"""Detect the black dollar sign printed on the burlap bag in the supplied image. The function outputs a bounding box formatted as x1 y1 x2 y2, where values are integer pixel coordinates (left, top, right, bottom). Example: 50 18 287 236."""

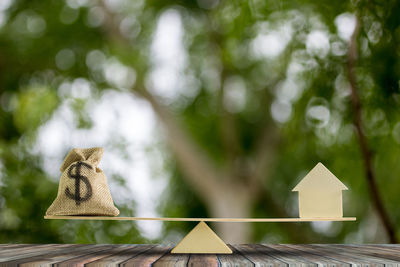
65 161 92 205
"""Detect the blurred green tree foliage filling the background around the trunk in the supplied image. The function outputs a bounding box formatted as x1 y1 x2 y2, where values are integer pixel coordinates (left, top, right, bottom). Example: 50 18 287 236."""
0 0 400 243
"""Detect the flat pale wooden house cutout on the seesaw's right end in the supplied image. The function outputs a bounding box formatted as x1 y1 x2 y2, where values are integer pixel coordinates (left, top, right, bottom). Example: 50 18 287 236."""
292 162 348 218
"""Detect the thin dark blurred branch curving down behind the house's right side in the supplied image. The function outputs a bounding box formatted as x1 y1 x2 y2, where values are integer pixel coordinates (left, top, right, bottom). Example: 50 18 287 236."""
347 17 398 243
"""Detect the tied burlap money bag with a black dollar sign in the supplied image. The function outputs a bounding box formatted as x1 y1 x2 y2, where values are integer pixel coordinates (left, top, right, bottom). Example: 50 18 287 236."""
46 147 119 216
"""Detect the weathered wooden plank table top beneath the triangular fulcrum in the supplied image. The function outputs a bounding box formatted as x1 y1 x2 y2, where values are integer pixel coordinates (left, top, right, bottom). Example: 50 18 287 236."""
0 244 400 267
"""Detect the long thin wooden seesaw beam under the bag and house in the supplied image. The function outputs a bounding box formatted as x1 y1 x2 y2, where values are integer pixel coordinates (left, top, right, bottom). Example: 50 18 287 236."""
44 215 356 222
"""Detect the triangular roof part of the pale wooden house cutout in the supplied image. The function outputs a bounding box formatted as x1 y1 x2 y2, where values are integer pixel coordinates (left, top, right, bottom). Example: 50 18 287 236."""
292 162 348 191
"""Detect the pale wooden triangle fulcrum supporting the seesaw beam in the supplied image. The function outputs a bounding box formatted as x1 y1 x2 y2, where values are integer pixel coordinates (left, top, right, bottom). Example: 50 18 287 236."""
171 221 232 254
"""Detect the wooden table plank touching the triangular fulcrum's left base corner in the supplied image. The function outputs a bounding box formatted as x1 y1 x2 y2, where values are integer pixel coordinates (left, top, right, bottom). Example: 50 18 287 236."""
117 245 171 267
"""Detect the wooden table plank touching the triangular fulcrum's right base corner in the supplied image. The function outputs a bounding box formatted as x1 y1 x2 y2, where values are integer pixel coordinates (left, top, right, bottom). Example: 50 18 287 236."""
233 244 287 267
